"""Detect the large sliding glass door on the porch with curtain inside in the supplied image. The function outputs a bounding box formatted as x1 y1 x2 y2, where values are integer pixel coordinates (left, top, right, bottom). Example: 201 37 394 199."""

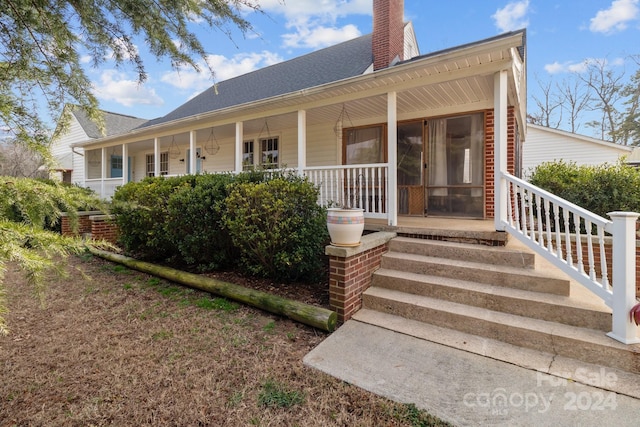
397 113 484 218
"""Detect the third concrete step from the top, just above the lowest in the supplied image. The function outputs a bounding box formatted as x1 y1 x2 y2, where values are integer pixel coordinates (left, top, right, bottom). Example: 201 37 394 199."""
372 268 611 332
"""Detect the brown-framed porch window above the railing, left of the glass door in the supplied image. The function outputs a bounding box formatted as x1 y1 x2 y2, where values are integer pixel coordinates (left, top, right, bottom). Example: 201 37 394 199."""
344 126 385 165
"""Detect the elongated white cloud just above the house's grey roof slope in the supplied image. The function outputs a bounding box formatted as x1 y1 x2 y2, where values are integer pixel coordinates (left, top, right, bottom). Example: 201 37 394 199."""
161 51 282 92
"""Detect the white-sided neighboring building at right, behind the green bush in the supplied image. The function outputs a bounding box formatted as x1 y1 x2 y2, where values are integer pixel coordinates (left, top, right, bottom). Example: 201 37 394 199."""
522 124 634 177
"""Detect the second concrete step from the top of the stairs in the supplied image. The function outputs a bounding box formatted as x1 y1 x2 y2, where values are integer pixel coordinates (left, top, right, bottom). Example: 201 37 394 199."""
381 252 570 296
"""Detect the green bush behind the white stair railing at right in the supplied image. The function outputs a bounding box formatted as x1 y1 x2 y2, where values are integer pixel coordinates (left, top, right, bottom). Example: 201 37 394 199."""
530 161 640 218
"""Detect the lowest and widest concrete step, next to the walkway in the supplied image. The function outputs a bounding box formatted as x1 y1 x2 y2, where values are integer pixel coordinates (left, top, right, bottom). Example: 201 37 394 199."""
363 287 640 374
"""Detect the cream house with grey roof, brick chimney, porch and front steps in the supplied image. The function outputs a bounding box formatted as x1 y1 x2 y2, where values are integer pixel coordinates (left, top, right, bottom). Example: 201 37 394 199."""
58 0 640 384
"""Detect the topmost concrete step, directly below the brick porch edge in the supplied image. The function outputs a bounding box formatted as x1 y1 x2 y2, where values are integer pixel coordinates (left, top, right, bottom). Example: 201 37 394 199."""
389 237 535 269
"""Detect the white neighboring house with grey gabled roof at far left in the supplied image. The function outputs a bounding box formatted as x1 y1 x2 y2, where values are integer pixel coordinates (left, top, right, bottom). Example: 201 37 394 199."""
51 105 147 186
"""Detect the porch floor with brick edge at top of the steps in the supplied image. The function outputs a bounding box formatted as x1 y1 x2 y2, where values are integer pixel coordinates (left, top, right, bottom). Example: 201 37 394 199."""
365 216 508 246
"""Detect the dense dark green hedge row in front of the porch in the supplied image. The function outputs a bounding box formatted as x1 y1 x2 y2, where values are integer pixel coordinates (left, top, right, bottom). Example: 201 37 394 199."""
112 171 328 280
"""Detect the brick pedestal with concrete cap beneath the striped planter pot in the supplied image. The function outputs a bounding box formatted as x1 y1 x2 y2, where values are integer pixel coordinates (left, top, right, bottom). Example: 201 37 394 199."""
325 232 396 323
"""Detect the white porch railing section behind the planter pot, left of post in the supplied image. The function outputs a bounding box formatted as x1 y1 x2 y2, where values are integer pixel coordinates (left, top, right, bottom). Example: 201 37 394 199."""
304 163 389 218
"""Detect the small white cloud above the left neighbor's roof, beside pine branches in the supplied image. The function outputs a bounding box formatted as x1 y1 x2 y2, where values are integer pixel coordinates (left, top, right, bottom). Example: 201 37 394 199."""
93 70 164 107
